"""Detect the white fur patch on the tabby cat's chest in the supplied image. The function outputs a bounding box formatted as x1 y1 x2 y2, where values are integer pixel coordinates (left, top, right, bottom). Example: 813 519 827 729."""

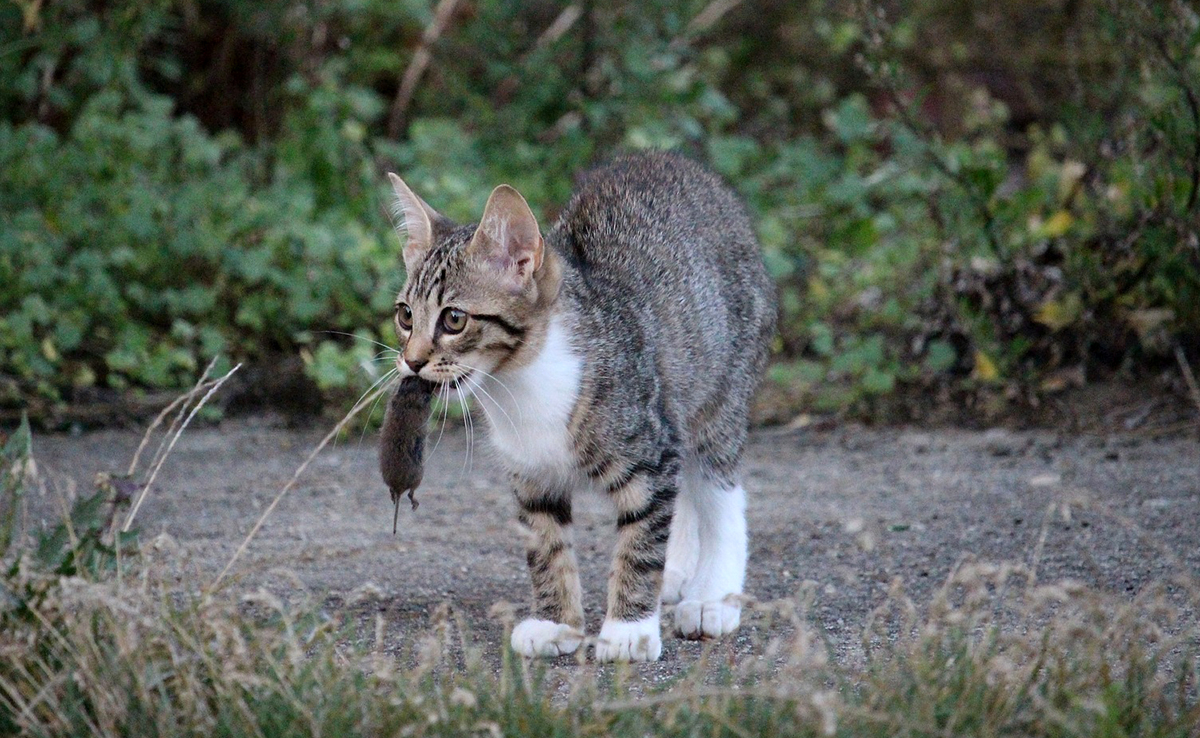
475 318 583 479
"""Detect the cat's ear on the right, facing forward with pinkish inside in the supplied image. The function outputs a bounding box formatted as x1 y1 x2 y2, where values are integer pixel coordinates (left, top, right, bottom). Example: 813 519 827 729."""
470 185 546 289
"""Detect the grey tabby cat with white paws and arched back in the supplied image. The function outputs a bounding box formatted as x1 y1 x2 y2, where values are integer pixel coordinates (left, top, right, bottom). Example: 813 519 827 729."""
389 152 776 661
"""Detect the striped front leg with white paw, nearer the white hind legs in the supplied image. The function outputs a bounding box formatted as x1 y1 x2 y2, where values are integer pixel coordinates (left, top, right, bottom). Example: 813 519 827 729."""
595 452 678 661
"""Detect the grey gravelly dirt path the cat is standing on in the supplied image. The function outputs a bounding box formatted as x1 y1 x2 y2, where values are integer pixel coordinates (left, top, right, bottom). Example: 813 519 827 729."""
35 420 1200 676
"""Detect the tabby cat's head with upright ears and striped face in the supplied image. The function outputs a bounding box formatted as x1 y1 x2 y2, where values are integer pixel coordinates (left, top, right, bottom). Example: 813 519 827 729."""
388 174 562 383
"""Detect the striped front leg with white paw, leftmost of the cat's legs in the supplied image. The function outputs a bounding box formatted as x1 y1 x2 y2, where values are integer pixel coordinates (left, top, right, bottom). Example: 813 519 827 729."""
511 479 583 656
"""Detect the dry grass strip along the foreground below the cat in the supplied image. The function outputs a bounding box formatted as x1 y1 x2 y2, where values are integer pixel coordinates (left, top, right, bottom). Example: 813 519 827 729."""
0 379 1200 737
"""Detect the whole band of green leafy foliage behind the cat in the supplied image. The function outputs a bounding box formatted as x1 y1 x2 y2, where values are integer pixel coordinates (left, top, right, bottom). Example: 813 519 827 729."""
0 0 1200 413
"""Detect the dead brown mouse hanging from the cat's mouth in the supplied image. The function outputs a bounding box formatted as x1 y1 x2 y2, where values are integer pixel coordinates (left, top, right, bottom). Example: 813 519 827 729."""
379 377 436 534
